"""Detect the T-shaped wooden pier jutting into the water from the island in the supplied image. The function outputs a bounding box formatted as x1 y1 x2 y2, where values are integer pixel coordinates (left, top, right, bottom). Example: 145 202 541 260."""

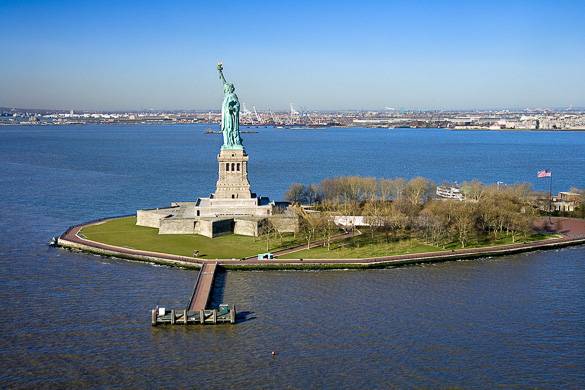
151 263 236 326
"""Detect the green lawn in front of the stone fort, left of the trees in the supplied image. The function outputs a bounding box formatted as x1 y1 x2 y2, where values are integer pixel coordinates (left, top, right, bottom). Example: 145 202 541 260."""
80 217 293 259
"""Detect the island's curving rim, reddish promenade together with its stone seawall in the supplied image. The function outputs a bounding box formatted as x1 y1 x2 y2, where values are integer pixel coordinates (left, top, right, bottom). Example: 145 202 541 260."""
55 217 585 271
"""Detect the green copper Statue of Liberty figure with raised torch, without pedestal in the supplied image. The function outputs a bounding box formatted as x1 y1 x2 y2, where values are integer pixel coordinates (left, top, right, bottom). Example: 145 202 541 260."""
217 63 244 150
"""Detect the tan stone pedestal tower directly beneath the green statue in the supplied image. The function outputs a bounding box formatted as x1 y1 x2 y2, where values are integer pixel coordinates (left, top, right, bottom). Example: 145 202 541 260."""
213 149 252 199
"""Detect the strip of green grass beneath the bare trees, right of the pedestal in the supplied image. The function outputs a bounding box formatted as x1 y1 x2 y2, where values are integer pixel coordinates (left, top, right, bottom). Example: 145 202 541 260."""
280 233 557 259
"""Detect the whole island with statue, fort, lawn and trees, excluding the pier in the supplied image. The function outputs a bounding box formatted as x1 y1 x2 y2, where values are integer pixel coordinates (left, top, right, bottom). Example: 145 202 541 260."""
57 63 585 269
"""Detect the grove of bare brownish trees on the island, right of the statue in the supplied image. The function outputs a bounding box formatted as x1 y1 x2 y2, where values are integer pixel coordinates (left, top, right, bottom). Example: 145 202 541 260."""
287 176 540 248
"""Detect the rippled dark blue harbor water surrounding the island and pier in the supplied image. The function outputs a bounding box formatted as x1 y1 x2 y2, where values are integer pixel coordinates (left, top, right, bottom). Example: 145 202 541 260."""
0 126 585 388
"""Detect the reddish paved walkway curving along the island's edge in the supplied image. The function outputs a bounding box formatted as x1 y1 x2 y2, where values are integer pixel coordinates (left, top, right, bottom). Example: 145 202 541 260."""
59 218 585 265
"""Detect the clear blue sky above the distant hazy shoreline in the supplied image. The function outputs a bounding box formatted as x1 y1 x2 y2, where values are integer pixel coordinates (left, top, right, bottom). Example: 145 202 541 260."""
0 0 585 110
